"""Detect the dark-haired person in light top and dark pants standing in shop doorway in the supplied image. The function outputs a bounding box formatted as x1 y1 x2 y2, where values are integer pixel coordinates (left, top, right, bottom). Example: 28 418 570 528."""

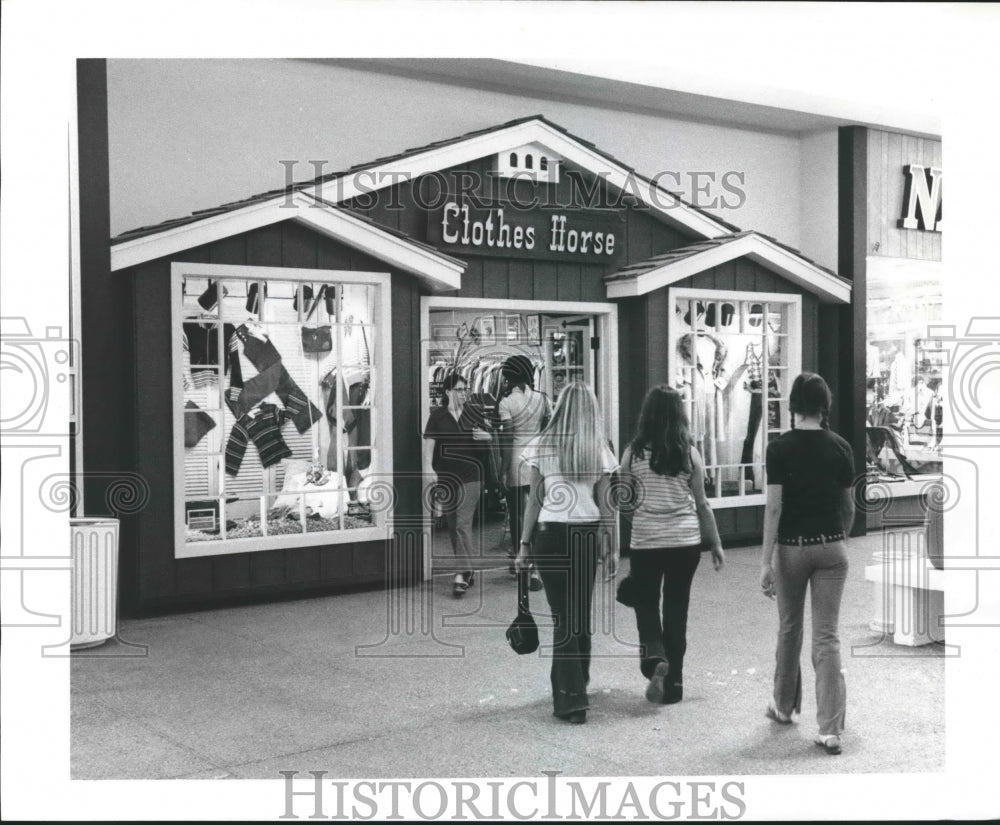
498 355 552 591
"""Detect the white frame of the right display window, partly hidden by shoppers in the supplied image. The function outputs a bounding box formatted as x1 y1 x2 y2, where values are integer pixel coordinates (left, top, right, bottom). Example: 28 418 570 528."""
667 287 802 510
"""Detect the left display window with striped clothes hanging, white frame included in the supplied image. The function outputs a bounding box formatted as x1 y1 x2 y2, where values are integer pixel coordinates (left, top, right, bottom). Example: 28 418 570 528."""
172 264 390 556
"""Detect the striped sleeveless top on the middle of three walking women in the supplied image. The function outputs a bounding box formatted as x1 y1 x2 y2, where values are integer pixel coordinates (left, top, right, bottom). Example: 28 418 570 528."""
631 455 701 550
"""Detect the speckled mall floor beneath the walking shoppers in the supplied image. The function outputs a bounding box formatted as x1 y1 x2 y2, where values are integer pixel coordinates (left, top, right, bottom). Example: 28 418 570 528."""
71 524 945 779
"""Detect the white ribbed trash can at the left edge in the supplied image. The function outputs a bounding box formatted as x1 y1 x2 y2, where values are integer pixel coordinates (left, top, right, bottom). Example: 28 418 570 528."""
69 518 118 650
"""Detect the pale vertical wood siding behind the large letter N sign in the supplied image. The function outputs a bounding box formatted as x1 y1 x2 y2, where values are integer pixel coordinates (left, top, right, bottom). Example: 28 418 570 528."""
865 129 943 261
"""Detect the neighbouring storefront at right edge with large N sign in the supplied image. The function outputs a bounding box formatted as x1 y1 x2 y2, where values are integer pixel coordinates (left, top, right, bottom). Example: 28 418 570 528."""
865 130 947 527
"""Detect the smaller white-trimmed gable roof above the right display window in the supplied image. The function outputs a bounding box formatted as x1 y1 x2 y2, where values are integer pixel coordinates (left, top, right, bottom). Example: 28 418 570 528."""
604 231 851 303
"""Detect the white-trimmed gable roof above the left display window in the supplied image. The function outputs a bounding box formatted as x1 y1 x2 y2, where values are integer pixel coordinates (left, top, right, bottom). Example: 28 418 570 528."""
111 192 466 291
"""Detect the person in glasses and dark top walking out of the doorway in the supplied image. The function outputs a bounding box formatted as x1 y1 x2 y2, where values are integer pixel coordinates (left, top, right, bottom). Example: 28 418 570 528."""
424 372 493 597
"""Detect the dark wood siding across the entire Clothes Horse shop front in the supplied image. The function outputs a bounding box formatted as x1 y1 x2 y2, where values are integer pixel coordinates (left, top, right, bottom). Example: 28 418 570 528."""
116 154 844 612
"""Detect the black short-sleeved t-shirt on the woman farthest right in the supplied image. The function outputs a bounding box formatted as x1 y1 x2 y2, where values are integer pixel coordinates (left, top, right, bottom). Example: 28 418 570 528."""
767 430 854 537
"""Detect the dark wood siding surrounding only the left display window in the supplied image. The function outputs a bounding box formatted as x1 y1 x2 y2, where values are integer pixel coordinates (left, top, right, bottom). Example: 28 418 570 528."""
125 222 420 612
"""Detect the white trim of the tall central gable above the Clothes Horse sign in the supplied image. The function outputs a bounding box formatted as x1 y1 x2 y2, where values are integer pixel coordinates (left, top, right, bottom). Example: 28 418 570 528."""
303 115 738 238
